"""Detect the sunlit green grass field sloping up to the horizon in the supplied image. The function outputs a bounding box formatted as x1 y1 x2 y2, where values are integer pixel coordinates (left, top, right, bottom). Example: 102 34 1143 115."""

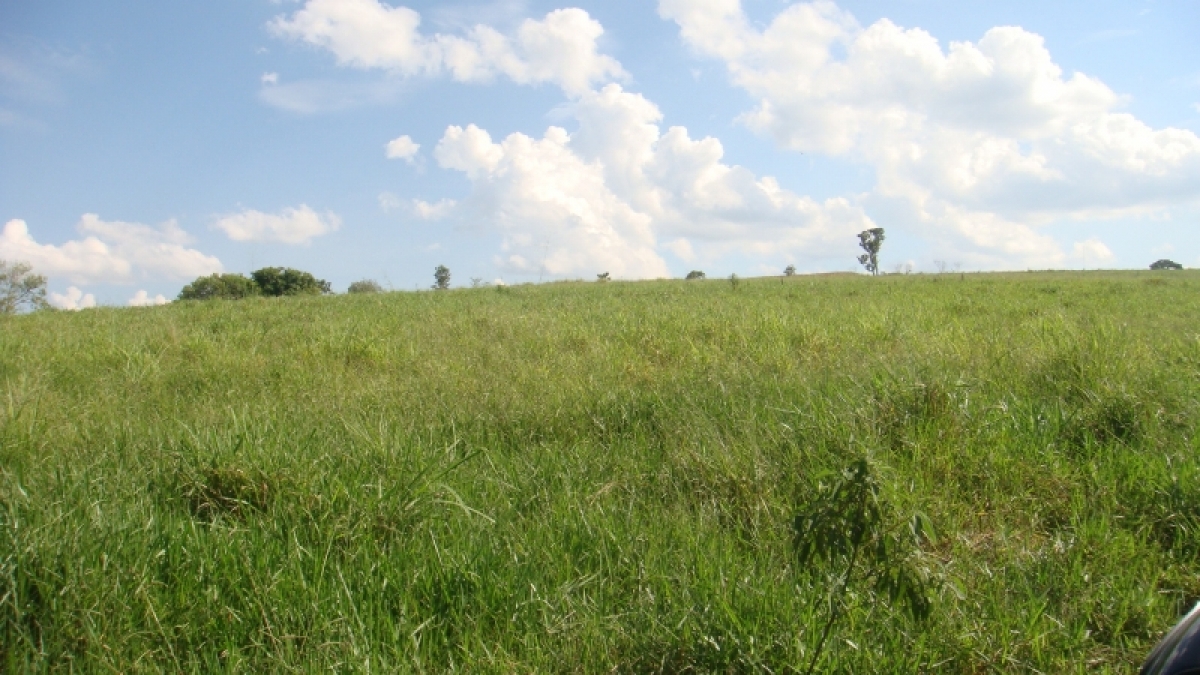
0 271 1200 673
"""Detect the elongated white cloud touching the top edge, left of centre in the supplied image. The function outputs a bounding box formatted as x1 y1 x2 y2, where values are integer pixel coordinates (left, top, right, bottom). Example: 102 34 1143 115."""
269 0 625 95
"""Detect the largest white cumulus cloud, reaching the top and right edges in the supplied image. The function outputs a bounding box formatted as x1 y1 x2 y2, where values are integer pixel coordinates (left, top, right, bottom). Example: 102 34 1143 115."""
659 0 1200 265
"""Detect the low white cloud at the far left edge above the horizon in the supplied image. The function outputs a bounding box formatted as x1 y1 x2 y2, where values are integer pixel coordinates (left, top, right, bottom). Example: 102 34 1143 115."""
0 214 222 281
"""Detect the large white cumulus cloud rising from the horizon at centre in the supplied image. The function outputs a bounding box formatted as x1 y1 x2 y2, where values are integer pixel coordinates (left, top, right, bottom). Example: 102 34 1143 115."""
433 84 872 277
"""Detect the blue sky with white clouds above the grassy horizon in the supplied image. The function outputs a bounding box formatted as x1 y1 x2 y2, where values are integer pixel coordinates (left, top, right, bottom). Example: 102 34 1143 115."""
0 0 1200 309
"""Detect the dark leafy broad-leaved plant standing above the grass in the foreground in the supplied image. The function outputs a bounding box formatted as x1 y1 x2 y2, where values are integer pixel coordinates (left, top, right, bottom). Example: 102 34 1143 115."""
792 459 934 673
